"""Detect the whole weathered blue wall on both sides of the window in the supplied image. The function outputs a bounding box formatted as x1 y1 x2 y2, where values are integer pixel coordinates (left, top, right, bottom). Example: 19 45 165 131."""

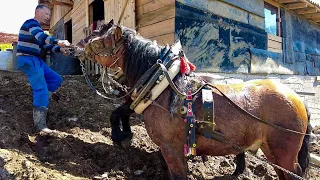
175 0 320 75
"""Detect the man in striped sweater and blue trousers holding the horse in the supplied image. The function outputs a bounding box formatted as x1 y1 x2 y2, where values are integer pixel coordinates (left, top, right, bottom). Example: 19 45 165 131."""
17 5 70 133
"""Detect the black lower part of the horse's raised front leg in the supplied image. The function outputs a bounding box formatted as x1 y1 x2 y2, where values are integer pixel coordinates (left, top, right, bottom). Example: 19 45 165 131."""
110 100 133 143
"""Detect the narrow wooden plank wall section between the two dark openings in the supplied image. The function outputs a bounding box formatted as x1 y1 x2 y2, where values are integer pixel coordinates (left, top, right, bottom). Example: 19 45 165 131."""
71 0 86 44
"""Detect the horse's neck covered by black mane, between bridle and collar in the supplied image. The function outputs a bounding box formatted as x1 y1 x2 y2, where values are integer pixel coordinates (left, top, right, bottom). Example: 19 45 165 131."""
124 36 163 87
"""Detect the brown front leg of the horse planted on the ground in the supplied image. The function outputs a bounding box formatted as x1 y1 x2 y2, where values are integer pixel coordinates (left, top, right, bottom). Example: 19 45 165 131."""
160 144 187 180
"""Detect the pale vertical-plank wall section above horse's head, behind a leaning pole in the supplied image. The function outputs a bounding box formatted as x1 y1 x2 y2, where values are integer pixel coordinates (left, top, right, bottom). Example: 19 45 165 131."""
104 0 136 29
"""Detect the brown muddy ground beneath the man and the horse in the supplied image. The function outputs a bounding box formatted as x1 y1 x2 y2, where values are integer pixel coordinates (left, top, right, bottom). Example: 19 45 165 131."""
0 71 320 180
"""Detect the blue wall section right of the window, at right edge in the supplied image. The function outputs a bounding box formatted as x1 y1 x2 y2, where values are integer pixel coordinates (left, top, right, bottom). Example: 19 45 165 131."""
281 10 320 75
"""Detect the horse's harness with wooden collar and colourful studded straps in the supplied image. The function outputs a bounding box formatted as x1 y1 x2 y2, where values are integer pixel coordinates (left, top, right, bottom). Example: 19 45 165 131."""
124 41 215 157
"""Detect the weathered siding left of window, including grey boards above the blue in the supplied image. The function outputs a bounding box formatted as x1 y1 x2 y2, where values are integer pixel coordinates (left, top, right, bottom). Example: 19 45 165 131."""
175 0 267 73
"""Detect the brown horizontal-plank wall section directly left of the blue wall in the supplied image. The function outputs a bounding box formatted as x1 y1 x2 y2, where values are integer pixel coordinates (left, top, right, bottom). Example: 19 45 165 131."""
136 0 176 45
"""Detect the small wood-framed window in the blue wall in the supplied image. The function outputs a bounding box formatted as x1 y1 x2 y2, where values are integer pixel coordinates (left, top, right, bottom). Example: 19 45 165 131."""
264 2 281 36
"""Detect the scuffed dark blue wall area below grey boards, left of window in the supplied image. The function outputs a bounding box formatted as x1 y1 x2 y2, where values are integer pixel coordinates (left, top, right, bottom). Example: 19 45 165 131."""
175 2 267 73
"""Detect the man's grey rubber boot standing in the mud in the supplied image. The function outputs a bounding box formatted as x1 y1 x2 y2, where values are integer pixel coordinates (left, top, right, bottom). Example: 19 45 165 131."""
33 106 56 133
